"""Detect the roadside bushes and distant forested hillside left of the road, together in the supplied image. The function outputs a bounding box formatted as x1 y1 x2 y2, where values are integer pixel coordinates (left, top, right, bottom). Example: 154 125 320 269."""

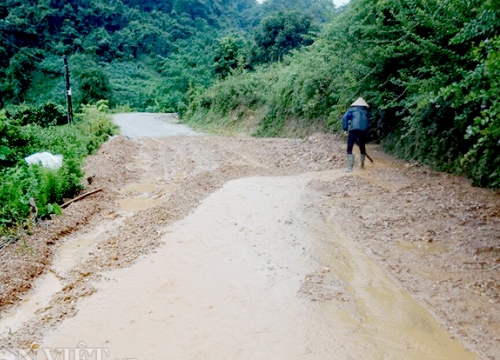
0 0 335 233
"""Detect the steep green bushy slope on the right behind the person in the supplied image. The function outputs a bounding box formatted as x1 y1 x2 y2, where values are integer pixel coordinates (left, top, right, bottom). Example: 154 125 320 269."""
188 0 500 188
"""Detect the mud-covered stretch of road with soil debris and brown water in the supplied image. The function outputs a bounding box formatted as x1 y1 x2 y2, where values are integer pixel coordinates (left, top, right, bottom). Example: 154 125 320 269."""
0 113 500 360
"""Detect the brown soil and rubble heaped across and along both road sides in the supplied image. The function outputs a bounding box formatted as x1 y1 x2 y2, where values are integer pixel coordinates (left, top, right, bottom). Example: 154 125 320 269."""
0 134 500 359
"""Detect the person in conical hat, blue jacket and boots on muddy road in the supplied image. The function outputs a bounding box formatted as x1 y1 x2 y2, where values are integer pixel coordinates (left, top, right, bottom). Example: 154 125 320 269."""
342 97 370 172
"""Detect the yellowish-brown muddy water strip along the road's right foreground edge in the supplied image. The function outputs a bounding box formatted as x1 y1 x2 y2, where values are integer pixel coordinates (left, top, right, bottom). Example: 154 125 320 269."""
316 220 475 360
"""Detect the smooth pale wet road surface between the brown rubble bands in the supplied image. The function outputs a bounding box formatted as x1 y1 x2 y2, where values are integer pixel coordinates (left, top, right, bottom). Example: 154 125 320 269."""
43 172 476 360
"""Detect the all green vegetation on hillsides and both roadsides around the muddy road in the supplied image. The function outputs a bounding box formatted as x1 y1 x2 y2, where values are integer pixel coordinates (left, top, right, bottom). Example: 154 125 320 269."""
0 0 500 242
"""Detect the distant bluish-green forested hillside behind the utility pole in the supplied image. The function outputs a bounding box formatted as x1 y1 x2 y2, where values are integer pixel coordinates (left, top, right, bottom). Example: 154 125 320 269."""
0 0 334 111
